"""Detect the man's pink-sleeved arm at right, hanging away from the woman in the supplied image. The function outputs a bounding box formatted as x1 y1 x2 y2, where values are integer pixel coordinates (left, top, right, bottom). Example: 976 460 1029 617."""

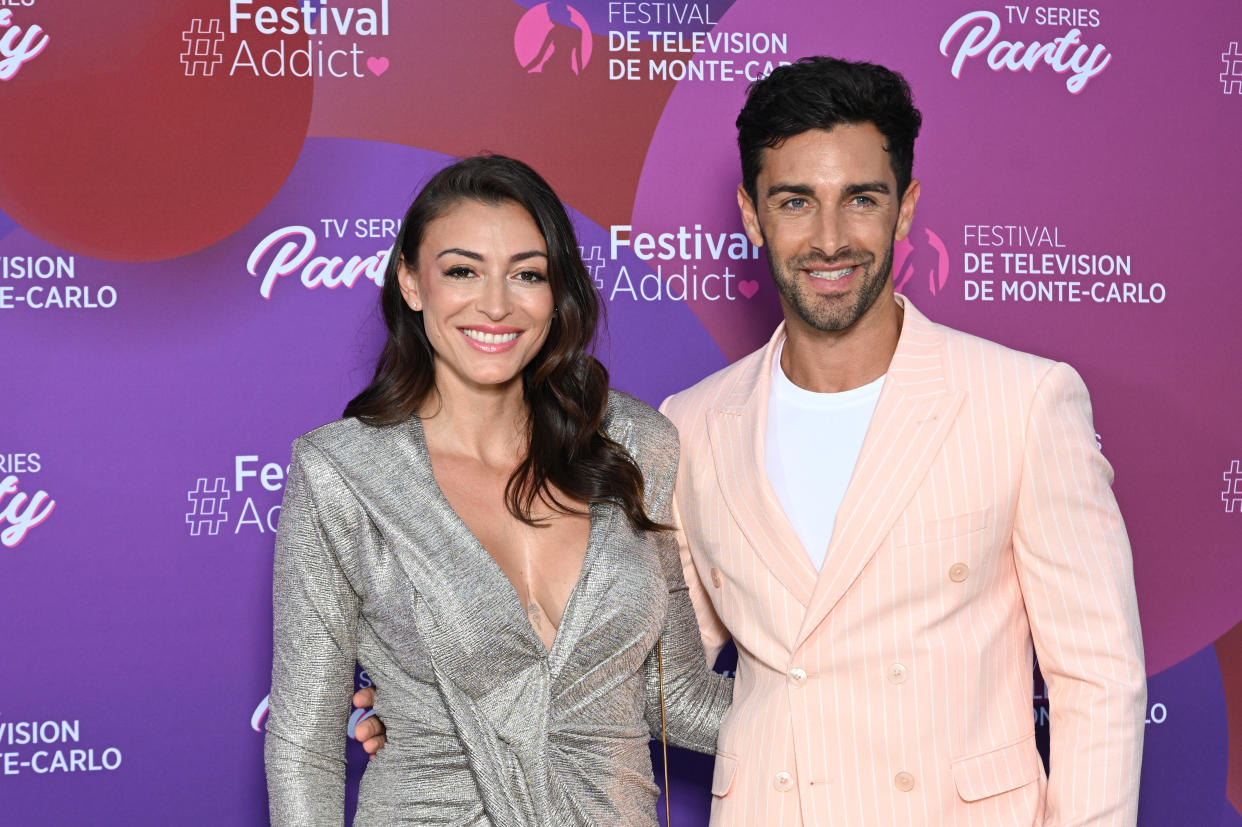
1013 364 1146 827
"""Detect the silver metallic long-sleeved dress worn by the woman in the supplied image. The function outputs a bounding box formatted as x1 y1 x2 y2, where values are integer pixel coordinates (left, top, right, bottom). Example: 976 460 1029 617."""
266 392 732 827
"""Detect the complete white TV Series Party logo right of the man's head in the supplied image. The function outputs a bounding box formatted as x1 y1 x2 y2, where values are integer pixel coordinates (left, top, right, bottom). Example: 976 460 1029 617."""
940 6 1113 94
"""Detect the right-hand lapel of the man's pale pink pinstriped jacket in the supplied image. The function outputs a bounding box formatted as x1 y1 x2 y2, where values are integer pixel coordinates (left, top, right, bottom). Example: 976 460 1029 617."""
797 297 965 646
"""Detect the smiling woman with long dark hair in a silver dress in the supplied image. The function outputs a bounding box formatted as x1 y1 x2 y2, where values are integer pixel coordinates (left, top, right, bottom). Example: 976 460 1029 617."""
266 155 732 827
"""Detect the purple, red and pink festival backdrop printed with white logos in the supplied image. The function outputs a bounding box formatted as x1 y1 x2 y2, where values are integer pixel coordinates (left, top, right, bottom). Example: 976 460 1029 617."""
0 0 1242 827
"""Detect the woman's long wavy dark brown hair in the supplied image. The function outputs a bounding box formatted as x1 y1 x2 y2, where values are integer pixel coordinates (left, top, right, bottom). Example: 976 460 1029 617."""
345 155 664 531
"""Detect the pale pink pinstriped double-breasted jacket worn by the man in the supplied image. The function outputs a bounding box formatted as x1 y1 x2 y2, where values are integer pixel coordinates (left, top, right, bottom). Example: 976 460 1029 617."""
662 298 1146 827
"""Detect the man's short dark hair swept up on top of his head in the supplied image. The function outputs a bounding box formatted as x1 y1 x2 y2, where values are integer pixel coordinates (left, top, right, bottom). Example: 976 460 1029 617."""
737 57 923 201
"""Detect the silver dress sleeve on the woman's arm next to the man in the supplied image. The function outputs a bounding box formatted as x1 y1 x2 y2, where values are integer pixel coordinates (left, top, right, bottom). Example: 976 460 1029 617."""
645 424 733 755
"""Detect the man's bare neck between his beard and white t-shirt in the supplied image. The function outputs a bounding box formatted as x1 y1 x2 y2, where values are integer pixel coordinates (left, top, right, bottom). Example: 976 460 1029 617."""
780 291 905 394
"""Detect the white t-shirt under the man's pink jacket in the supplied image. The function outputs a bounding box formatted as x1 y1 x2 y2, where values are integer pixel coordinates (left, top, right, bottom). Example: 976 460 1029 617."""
764 343 884 569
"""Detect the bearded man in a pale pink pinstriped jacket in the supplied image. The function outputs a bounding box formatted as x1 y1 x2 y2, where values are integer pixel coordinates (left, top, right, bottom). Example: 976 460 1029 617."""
364 58 1146 827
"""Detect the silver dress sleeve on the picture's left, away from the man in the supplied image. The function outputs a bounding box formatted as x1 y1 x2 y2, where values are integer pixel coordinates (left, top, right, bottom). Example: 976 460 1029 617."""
263 440 359 827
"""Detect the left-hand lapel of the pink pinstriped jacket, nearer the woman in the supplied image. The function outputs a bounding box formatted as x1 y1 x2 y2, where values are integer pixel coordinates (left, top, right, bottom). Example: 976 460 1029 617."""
707 324 817 606
